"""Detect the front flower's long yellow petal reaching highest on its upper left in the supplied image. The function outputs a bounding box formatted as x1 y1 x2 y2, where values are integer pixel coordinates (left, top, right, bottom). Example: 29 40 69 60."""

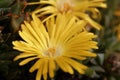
31 14 49 48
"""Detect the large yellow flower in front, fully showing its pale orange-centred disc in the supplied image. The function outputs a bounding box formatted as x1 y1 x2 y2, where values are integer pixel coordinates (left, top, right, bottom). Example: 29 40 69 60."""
13 15 97 80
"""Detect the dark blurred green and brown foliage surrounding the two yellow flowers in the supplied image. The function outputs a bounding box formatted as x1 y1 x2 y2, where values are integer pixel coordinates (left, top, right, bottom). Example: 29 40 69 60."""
0 0 120 80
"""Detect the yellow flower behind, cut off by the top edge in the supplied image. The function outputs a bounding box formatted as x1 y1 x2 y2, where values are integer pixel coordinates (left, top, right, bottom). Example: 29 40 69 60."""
27 0 106 30
